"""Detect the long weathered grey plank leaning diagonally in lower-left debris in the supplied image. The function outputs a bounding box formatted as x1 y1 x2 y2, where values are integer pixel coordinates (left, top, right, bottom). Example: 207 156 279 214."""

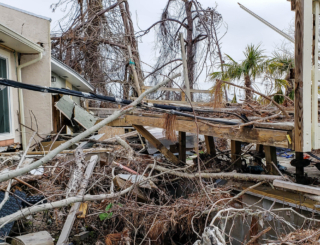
57 156 98 245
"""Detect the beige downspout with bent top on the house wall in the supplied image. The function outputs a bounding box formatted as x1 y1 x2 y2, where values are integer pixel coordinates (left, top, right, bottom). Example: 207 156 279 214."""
17 52 43 150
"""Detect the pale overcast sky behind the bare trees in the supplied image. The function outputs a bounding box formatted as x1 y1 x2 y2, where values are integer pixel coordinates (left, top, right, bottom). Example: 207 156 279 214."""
0 0 294 92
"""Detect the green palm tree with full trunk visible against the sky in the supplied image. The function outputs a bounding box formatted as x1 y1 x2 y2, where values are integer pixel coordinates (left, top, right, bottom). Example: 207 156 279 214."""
211 44 266 101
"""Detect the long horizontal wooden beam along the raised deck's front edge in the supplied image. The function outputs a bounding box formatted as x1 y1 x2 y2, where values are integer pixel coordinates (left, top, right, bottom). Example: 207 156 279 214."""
125 115 292 149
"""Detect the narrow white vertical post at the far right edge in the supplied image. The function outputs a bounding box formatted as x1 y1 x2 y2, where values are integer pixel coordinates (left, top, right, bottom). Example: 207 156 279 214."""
311 2 320 149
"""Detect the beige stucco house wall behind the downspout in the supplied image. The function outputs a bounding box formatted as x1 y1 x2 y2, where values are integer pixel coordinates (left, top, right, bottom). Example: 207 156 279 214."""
0 6 52 146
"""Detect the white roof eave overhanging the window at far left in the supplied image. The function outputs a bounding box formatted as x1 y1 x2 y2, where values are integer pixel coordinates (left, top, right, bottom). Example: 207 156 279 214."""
0 24 44 54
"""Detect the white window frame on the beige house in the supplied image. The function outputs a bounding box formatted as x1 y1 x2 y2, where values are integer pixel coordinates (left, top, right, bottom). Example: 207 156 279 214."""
0 49 15 141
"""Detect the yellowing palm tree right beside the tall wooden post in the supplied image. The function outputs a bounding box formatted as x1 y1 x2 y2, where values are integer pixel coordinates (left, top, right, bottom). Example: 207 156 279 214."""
266 52 294 104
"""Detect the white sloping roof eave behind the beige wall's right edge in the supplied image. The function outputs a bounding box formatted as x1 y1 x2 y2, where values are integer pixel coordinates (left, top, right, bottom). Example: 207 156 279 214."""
51 57 93 92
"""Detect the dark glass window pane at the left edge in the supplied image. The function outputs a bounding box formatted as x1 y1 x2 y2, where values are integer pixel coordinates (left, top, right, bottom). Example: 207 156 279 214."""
0 57 10 134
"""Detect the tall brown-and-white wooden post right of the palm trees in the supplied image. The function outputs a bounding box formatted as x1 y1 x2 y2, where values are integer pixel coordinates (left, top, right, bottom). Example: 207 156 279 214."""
294 0 313 152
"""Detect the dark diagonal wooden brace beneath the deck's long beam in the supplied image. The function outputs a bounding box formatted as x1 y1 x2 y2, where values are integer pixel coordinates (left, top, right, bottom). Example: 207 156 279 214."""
132 125 180 164
